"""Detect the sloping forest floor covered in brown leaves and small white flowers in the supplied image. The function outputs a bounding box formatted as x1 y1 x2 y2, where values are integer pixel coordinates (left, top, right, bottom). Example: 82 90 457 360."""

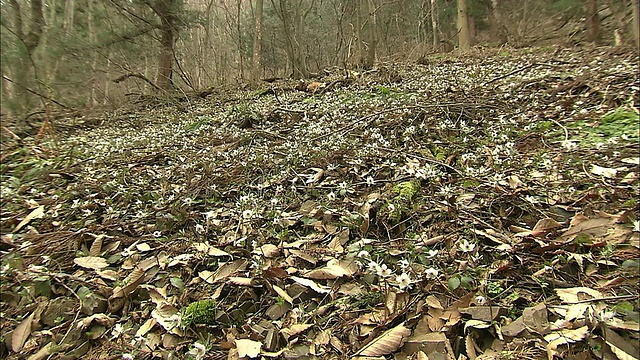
0 49 640 359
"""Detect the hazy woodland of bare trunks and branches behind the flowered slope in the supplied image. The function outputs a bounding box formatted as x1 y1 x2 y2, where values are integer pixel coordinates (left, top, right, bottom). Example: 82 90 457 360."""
0 0 640 115
